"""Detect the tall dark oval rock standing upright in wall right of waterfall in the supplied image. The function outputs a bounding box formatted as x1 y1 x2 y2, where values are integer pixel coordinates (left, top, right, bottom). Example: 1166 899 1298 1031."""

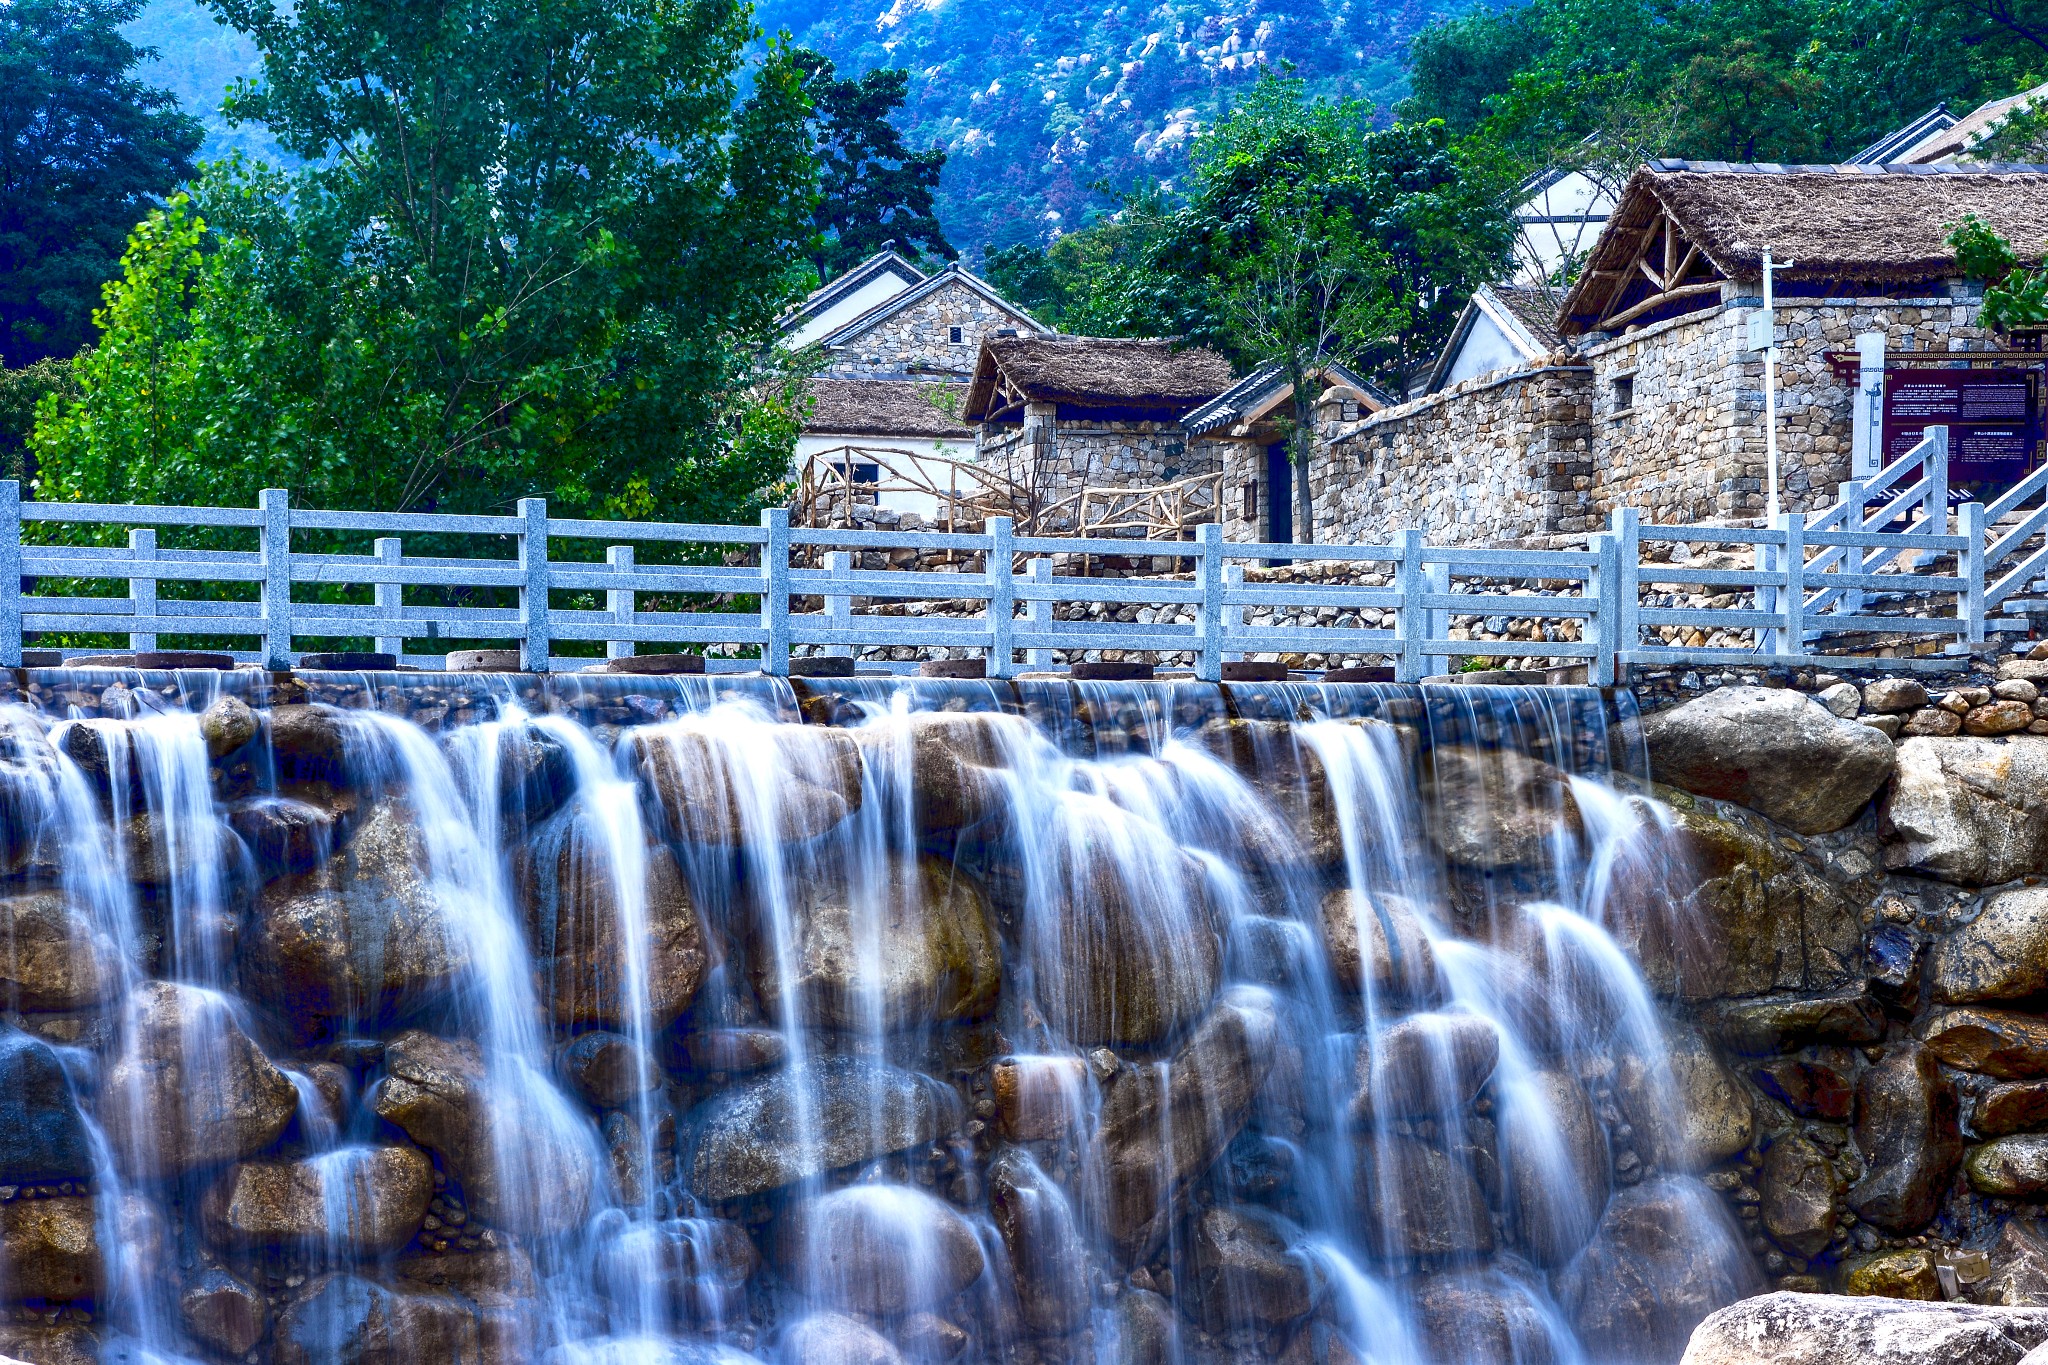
1849 1044 1962 1232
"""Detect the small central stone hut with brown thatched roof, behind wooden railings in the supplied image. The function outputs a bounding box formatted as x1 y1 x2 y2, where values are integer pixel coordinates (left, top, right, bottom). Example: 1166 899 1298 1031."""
961 336 1233 532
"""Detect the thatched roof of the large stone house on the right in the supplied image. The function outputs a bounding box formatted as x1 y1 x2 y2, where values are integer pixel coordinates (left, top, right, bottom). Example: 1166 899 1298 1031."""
1559 162 2048 334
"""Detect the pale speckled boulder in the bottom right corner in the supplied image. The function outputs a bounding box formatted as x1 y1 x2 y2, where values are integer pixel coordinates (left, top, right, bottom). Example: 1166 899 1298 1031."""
1681 1293 2048 1365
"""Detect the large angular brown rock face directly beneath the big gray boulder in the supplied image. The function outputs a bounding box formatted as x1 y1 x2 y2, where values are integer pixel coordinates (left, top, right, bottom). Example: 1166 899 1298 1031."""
1647 794 1868 1001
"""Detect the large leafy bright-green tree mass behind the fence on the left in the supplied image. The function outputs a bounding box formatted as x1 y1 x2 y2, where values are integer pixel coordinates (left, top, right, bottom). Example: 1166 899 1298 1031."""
35 0 813 520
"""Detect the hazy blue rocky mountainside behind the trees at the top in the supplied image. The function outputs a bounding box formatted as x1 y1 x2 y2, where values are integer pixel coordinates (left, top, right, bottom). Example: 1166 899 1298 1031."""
129 0 1464 268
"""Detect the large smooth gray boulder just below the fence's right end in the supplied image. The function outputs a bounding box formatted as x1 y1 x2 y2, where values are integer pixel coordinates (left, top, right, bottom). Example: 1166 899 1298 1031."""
1642 688 1892 835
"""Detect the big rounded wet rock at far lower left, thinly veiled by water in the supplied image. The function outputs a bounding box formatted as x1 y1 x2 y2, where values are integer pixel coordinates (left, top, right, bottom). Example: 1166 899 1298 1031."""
98 980 299 1175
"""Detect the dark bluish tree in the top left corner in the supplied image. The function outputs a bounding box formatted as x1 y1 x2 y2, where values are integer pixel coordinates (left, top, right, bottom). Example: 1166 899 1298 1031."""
0 0 201 368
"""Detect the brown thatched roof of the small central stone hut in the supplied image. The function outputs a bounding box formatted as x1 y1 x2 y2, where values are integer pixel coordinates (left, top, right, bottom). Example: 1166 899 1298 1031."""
963 336 1231 422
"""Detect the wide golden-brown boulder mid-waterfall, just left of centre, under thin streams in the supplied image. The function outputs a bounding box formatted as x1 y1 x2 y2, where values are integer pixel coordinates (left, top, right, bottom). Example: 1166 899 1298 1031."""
754 857 1004 1029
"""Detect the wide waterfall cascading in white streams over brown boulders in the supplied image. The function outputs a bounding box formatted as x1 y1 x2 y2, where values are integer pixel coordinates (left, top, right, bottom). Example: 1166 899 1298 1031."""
0 673 1751 1365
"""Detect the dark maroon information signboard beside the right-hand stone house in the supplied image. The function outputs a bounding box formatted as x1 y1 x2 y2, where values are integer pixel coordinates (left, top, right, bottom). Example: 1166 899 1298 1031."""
1884 368 2042 485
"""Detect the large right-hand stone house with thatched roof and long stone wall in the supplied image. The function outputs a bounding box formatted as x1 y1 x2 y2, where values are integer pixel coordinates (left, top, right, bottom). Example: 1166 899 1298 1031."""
1311 162 2048 542
